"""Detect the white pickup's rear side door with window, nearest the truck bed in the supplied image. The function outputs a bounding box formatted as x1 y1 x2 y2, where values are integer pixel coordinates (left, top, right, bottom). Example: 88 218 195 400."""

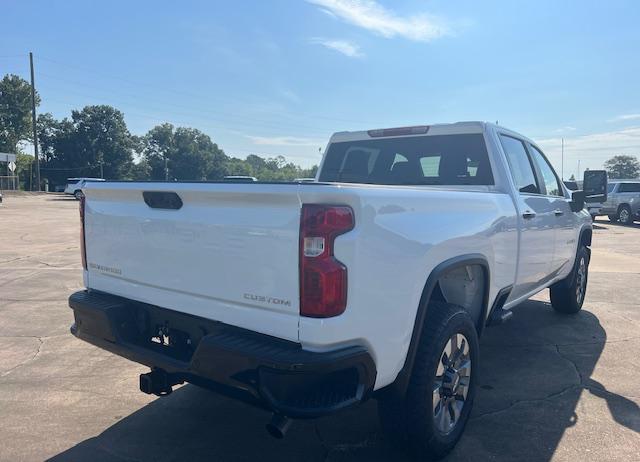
499 133 555 300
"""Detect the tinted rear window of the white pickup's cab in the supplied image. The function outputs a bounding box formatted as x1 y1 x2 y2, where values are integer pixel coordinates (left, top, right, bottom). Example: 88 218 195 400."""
319 134 494 185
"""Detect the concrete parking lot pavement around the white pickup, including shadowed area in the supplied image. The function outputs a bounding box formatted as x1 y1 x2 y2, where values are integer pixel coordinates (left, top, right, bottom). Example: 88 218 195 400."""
0 195 640 462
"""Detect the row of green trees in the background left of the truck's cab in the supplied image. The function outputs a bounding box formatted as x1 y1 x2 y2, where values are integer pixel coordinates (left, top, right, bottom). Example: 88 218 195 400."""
0 71 317 190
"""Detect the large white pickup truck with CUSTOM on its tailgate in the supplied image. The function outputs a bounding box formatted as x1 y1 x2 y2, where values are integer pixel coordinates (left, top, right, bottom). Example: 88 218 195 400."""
69 122 606 457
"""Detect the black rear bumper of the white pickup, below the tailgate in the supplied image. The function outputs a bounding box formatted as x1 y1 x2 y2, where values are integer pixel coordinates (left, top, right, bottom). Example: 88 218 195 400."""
69 291 376 418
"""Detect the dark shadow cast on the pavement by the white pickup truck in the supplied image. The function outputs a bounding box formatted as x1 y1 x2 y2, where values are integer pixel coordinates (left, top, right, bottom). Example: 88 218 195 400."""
51 301 639 462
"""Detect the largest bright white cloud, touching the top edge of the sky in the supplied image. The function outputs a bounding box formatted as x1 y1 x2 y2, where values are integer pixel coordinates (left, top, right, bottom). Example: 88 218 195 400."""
307 0 451 42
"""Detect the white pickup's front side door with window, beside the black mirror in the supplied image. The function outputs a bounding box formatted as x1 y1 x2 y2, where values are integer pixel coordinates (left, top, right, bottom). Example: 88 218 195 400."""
527 143 578 276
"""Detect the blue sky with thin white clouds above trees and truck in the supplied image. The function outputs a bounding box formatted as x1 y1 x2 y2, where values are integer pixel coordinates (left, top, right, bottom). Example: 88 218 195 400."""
0 0 640 178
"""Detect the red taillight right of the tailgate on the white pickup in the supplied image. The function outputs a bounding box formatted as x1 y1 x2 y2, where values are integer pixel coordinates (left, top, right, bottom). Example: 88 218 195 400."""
300 204 354 318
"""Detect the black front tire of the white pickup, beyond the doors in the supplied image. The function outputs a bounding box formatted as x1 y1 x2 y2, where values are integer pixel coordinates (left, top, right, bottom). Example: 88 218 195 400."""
549 246 589 314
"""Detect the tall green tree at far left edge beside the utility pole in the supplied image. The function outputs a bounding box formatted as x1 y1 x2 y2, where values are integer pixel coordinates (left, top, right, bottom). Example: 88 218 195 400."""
0 74 40 152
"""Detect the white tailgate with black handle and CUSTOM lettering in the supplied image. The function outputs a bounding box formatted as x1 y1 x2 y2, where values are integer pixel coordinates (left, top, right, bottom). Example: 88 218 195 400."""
85 182 300 341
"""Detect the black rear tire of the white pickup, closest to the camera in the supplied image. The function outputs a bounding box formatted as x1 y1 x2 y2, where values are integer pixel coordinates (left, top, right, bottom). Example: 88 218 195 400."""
378 302 479 460
